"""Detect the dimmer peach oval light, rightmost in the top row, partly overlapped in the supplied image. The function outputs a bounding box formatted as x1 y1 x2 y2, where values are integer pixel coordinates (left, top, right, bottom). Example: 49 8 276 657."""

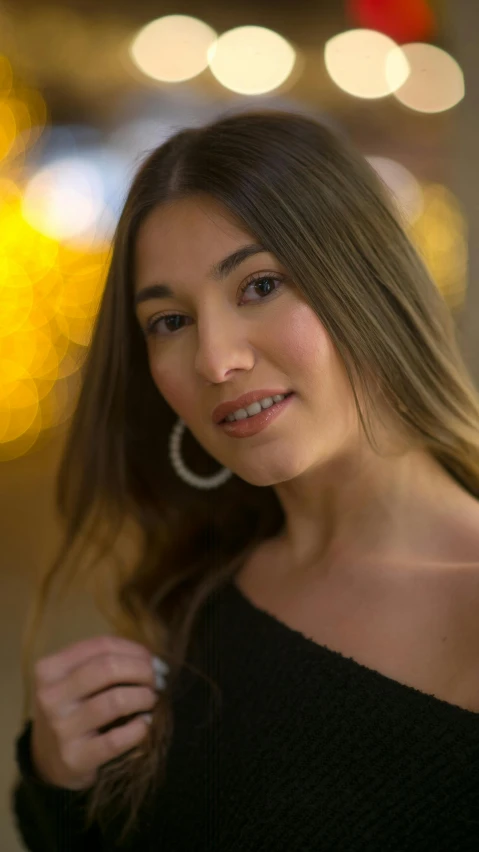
390 42 464 112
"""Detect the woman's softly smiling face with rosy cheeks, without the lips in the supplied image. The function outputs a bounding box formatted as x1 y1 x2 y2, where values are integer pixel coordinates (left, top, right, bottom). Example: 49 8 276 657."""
135 196 358 485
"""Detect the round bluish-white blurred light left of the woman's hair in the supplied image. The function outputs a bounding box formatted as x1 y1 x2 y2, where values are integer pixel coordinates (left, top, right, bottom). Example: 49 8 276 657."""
23 158 103 239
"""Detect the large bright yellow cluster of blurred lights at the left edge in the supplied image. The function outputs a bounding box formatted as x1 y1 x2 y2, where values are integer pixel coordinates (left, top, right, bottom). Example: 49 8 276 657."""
0 172 109 461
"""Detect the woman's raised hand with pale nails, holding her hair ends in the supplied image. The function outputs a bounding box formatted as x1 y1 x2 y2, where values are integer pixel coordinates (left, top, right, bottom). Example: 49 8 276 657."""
31 636 168 790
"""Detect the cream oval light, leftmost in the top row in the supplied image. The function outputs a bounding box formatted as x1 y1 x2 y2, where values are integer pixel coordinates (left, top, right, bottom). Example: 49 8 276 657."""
130 15 216 83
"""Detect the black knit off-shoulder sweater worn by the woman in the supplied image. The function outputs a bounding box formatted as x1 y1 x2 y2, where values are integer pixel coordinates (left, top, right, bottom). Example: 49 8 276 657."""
13 582 479 852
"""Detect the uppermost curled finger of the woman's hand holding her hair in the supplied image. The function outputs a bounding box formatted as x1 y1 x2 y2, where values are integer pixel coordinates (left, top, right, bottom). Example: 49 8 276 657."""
35 636 151 684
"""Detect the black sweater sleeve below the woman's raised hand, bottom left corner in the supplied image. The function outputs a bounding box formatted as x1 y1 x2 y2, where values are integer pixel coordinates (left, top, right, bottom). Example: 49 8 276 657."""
11 720 102 852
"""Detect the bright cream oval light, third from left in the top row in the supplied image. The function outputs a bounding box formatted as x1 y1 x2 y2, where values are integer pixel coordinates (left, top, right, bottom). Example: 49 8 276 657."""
324 30 409 98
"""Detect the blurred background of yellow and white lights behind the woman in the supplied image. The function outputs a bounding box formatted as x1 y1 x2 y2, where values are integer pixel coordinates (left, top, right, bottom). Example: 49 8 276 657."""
0 0 479 852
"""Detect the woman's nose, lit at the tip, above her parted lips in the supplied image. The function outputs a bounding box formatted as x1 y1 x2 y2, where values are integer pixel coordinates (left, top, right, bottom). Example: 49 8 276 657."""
195 310 255 384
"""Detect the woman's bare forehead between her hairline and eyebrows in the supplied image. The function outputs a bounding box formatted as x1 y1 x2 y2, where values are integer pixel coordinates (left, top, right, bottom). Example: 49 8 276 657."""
131 197 252 288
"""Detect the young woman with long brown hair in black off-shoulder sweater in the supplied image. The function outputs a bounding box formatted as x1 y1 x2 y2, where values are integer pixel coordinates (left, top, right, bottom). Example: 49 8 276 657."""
14 112 479 852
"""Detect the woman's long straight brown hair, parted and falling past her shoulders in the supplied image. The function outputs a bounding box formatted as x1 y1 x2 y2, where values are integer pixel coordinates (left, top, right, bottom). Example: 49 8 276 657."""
20 111 479 844
